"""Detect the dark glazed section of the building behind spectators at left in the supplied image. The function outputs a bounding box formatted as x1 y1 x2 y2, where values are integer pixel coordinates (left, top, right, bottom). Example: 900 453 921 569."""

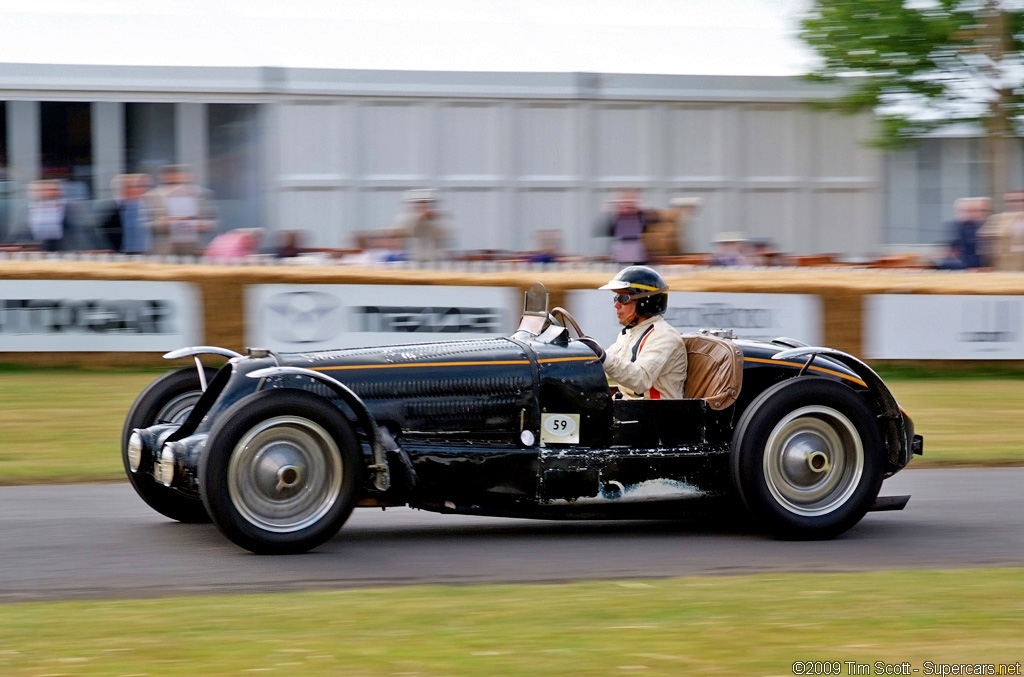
0 101 266 247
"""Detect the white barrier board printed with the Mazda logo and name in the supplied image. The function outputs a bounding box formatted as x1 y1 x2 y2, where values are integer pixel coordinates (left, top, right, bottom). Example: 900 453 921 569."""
246 285 522 352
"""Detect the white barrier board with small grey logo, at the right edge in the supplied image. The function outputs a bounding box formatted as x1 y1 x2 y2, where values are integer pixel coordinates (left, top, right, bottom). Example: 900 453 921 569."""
863 294 1024 359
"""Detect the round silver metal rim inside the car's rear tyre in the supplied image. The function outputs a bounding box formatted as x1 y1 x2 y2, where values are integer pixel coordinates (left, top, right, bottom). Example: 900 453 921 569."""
764 406 864 517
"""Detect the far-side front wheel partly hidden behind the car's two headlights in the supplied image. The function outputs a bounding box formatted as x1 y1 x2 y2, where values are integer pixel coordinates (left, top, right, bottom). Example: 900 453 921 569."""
121 367 217 523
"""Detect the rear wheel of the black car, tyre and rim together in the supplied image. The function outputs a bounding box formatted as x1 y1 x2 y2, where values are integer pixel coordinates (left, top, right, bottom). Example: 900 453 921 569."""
731 377 885 540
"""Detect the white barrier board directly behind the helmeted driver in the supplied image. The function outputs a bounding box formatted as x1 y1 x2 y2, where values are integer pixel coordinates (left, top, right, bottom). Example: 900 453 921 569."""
566 290 821 345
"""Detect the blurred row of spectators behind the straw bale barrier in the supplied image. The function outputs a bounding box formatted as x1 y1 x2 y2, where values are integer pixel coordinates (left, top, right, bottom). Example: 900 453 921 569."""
0 165 1024 270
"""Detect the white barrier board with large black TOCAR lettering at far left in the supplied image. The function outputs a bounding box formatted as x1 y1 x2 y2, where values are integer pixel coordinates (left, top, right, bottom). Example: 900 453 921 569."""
0 280 203 352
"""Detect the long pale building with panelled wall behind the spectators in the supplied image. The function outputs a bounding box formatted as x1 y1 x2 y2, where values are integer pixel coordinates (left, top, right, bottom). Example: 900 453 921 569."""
0 64 999 255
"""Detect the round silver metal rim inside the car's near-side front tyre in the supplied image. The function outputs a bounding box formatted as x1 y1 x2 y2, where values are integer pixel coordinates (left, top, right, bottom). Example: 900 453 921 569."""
227 416 343 533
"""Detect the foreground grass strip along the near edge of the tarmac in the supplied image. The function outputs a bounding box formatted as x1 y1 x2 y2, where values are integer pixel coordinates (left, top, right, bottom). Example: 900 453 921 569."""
0 569 1024 676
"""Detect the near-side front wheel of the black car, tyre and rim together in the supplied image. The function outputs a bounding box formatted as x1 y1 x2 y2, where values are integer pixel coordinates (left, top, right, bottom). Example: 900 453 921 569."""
199 389 362 554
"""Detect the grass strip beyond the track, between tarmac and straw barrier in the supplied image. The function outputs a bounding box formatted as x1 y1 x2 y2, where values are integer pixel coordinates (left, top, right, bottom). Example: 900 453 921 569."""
0 367 1024 484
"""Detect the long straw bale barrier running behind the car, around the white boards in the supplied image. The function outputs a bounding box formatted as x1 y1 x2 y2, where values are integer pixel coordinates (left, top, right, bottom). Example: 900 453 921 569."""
6 260 1024 367
